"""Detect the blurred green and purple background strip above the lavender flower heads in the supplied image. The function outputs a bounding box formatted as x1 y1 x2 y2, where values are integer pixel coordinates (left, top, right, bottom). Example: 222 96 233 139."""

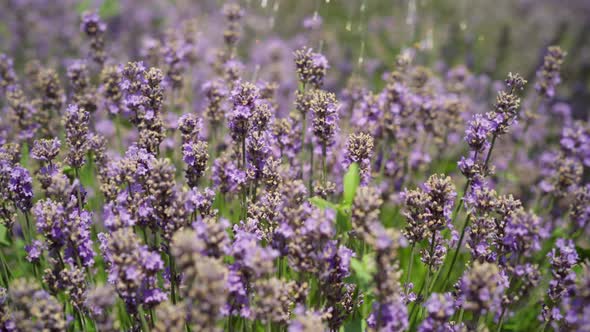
0 0 590 114
